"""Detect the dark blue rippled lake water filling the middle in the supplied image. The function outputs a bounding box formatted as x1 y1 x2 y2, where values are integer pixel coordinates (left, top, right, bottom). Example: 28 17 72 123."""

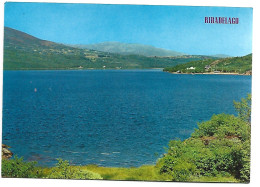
3 70 251 167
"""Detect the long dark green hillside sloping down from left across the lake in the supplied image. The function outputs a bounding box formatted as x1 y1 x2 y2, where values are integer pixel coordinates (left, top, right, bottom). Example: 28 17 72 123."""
4 27 216 70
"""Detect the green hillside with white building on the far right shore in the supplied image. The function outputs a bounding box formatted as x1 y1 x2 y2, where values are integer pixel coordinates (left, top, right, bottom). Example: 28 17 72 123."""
164 54 252 75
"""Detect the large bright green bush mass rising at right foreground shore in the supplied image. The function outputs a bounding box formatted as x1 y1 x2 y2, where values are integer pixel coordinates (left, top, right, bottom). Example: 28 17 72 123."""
157 96 251 182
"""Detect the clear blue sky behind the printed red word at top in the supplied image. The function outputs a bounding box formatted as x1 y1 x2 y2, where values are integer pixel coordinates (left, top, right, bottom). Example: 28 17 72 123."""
4 3 252 56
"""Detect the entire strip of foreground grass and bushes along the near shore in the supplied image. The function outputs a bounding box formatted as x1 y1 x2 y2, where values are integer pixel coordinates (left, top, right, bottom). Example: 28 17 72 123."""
2 94 251 183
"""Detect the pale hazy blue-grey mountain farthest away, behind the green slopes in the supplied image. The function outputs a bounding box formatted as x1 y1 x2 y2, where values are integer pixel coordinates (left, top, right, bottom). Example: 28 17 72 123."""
71 42 186 57
